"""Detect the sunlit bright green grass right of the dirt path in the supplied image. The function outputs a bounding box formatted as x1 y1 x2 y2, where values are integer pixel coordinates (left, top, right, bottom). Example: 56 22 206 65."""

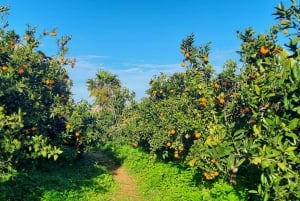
112 146 248 201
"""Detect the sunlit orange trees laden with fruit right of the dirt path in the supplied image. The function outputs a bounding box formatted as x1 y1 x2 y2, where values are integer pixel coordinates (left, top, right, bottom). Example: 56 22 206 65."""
121 1 300 200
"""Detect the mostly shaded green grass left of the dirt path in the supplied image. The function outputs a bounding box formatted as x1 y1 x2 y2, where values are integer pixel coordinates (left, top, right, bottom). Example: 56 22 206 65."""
0 155 115 201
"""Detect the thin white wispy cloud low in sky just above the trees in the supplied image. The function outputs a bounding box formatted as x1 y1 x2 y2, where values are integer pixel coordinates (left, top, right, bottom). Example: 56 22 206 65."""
69 49 237 100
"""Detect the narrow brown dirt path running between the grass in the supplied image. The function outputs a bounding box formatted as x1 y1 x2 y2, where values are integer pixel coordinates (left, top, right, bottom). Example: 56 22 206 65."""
91 152 141 201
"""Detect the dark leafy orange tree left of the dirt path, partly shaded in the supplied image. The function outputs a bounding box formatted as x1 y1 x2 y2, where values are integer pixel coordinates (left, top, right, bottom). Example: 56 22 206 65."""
0 6 95 170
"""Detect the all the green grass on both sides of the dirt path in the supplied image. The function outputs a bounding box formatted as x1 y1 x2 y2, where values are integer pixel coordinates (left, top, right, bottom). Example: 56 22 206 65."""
0 145 247 201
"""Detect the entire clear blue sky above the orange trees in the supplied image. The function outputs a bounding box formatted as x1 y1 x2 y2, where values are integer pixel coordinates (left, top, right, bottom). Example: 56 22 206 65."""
1 0 290 101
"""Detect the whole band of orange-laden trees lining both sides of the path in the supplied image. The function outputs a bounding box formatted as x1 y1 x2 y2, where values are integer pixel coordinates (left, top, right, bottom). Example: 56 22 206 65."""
0 0 300 200
